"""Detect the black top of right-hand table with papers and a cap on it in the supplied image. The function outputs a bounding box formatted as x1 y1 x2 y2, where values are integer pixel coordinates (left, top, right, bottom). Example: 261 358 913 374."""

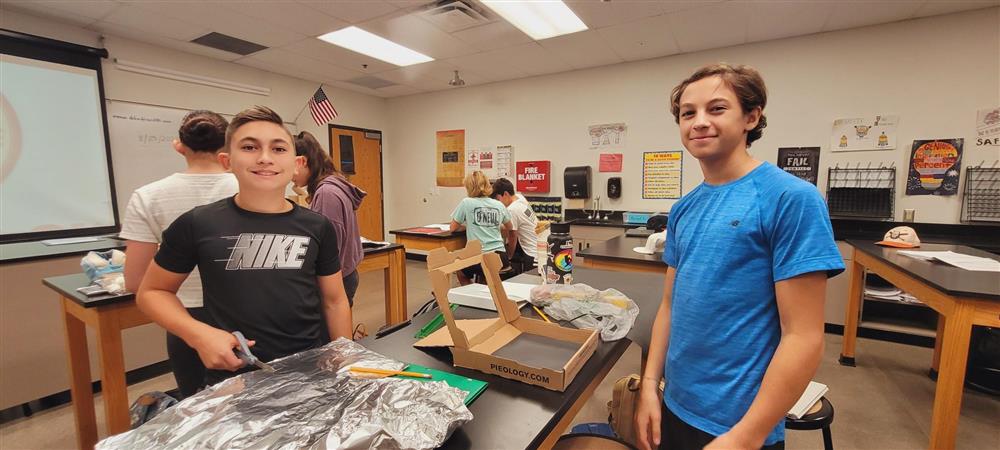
847 239 1000 301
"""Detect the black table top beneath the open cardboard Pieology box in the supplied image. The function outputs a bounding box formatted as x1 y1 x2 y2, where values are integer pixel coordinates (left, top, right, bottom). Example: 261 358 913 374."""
359 290 629 449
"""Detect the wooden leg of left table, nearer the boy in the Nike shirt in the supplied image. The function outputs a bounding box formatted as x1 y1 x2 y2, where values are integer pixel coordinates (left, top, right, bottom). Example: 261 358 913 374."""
97 310 131 435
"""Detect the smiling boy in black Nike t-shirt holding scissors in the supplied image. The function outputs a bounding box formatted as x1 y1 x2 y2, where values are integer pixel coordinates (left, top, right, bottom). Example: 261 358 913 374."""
136 106 351 384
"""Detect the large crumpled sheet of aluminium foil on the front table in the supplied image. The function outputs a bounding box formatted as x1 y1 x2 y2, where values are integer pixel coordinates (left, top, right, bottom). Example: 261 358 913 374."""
96 338 472 450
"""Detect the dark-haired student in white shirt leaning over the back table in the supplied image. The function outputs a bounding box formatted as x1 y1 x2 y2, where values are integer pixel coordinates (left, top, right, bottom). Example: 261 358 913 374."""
493 178 538 268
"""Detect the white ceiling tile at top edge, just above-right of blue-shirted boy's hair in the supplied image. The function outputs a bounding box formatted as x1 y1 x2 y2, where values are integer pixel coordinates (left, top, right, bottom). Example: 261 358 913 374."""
747 0 834 42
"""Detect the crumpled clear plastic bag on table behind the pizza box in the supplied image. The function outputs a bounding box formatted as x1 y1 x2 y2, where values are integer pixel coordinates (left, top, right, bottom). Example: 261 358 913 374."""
528 284 639 341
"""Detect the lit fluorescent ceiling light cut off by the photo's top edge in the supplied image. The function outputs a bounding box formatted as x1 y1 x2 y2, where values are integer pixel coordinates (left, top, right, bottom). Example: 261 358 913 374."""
480 0 587 41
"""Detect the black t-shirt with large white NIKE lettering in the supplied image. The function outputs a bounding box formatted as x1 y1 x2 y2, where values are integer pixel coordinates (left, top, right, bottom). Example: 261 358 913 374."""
155 197 340 361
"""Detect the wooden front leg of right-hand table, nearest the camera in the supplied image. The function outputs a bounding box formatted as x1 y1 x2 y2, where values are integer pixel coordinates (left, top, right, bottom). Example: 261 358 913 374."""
929 302 974 449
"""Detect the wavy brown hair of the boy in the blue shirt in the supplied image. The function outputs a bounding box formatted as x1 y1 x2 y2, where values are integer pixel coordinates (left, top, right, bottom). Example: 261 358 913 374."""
670 63 767 148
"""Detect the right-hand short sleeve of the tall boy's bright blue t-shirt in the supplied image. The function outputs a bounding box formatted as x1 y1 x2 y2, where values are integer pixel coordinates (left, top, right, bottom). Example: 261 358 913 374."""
771 186 844 282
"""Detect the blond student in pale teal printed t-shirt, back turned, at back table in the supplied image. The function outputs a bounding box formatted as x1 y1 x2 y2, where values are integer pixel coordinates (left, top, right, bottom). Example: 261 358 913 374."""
451 170 511 285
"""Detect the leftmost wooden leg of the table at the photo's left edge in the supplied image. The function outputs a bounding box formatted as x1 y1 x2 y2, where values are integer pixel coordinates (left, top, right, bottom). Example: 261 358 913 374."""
61 298 97 450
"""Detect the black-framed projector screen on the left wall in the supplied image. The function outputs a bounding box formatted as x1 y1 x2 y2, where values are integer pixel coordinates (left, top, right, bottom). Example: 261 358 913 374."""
0 31 118 242
